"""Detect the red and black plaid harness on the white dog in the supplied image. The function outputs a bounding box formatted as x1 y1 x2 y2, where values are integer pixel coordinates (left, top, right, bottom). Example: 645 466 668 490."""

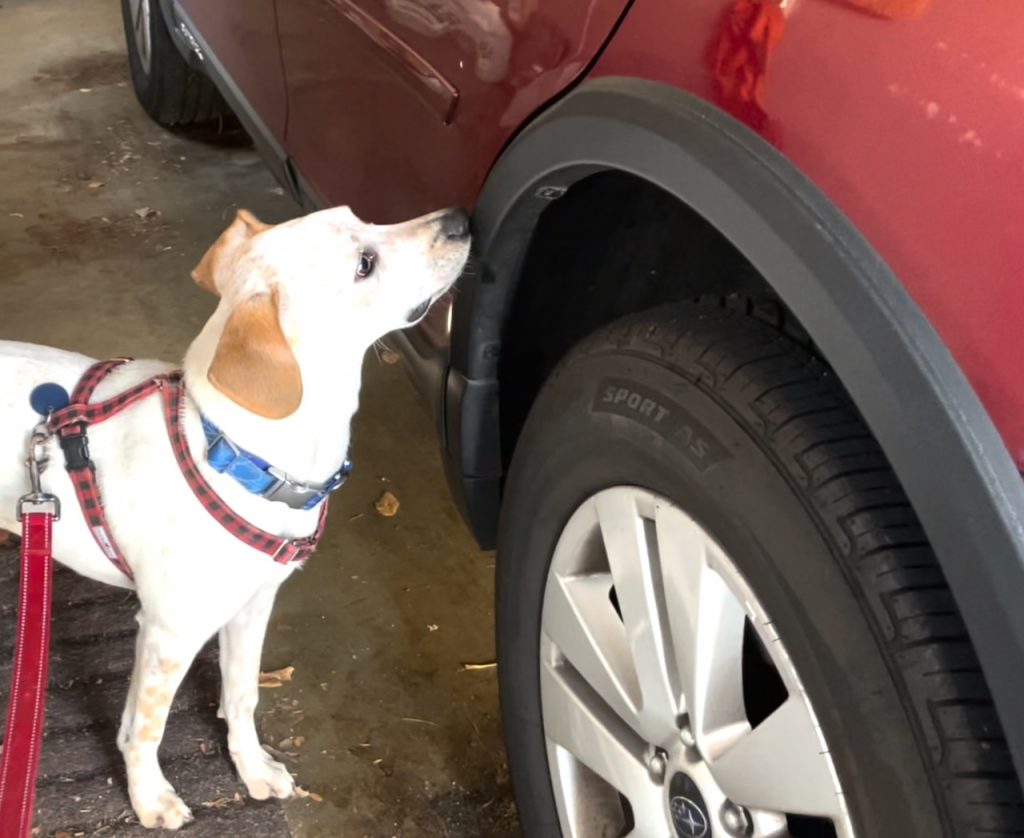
47 359 328 579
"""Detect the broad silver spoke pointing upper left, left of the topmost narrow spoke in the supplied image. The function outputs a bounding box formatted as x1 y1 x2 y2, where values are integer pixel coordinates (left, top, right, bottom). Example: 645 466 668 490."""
544 574 640 728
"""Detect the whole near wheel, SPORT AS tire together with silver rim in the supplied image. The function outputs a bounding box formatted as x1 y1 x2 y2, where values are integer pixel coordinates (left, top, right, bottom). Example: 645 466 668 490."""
497 304 1024 838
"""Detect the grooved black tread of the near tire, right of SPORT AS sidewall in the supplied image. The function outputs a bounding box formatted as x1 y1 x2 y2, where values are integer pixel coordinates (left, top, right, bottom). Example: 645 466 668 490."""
565 301 1024 838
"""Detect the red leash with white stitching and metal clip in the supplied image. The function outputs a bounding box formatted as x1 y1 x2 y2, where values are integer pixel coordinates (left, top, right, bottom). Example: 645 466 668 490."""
0 428 60 838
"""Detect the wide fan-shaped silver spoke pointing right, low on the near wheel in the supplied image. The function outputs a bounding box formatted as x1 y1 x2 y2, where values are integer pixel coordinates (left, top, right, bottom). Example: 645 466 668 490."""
709 694 844 818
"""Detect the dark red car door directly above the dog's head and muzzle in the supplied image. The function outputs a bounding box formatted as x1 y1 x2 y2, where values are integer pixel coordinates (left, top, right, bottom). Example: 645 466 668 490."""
278 0 627 222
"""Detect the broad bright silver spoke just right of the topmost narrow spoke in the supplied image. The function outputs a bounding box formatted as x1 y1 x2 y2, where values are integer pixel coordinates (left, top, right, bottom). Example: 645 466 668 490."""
656 506 750 758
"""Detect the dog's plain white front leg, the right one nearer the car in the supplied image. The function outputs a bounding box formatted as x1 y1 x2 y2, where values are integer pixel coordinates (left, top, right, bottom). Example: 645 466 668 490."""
220 584 295 800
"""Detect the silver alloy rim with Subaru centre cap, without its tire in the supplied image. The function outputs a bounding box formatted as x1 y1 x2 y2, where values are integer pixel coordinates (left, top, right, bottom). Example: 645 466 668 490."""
541 487 854 838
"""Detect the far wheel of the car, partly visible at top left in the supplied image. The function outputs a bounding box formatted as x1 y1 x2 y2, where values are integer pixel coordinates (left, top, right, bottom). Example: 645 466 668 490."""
121 0 228 127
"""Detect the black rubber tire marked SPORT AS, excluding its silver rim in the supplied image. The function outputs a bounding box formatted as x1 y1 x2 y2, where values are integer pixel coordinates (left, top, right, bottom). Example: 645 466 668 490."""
496 303 1024 838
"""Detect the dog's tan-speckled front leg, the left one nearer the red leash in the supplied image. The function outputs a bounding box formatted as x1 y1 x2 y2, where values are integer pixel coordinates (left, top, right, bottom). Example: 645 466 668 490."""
118 610 204 829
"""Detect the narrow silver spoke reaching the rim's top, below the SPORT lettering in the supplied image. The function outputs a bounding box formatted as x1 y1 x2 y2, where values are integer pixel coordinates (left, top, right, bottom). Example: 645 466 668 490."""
596 490 679 743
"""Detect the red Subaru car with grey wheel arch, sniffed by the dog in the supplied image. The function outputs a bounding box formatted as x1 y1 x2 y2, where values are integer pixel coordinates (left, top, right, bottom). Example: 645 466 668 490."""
117 0 1024 838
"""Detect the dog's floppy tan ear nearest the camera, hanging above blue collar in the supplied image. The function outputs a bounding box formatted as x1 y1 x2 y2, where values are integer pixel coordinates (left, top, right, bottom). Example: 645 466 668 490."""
207 288 302 419
